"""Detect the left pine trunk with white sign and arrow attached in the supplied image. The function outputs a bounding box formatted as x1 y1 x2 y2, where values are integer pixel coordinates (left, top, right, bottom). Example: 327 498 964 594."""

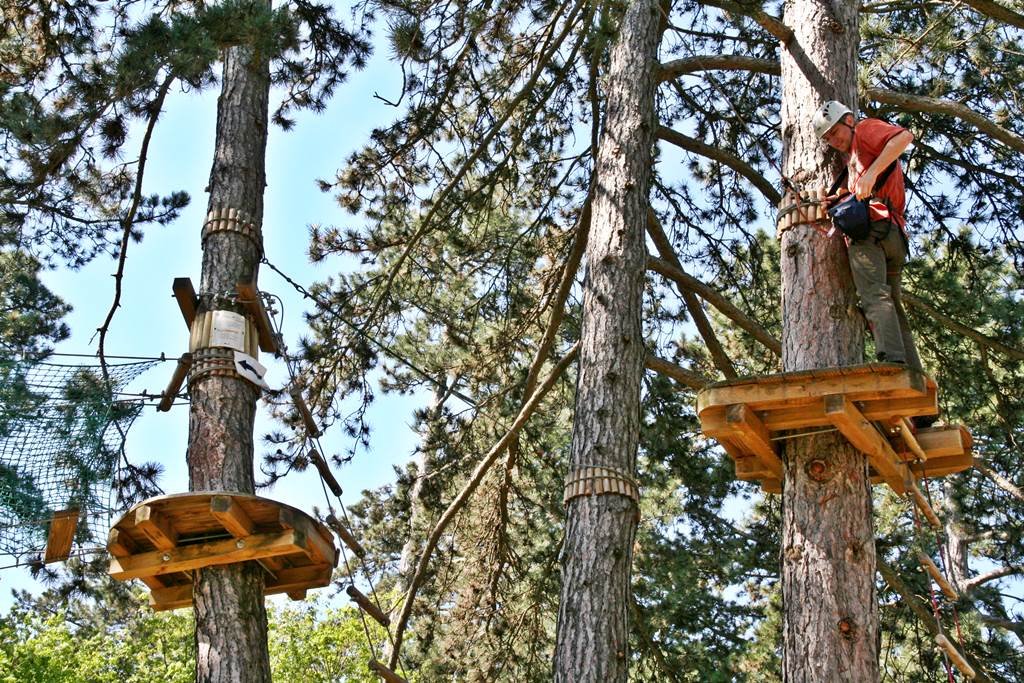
187 6 270 683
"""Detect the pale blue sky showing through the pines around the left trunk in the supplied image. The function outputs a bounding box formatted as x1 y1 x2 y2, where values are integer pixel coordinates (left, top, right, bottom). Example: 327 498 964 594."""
0 25 422 613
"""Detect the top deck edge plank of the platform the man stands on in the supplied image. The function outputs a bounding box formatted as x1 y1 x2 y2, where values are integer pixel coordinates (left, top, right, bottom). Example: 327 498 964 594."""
697 366 929 414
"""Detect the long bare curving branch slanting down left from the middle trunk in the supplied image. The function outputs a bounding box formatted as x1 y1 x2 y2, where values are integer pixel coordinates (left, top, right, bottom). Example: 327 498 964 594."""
389 342 580 669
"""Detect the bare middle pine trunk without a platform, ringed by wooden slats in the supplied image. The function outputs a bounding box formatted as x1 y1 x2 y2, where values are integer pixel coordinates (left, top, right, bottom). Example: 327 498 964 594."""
554 0 659 683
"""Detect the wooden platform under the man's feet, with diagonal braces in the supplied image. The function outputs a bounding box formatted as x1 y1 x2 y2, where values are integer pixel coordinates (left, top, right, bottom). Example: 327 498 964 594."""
697 362 972 494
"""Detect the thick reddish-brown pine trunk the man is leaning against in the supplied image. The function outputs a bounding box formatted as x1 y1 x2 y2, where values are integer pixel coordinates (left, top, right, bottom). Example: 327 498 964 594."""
781 0 879 683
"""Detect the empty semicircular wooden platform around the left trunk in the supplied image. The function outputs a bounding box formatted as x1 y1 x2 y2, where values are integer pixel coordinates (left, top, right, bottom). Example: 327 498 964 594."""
106 492 338 610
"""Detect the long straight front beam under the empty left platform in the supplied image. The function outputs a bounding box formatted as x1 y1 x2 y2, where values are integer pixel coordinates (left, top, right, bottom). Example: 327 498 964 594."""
110 529 308 581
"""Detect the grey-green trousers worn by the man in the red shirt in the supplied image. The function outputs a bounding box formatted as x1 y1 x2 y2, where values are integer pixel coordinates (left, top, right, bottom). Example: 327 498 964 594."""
849 221 922 370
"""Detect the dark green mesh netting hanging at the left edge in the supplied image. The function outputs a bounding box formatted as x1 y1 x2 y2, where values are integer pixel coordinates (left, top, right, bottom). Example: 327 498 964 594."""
0 360 159 556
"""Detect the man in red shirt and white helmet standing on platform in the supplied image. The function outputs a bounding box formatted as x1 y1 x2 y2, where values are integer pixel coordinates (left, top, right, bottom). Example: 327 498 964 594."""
814 100 922 370
